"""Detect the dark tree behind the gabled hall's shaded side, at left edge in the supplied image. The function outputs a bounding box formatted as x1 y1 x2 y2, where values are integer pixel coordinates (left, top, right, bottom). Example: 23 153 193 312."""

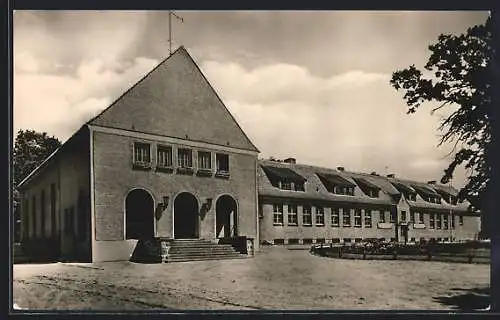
12 130 61 242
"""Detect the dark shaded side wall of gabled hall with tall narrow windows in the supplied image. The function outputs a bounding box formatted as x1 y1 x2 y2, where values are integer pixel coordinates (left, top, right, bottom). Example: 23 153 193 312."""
20 131 90 261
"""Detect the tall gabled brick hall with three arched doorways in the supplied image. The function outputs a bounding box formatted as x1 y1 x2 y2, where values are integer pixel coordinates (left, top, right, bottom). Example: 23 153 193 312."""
19 47 258 261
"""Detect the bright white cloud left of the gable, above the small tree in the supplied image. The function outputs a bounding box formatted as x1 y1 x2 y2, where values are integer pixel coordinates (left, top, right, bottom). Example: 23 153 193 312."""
14 53 158 140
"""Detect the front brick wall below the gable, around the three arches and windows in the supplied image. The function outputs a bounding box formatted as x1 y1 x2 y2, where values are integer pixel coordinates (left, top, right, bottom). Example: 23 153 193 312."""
93 129 257 261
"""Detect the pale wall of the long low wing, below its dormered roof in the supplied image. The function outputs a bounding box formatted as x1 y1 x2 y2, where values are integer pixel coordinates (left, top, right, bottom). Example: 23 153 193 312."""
259 197 480 244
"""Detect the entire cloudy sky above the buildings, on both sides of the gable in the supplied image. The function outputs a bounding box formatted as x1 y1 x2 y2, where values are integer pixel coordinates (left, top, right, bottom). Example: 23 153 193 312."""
13 11 488 187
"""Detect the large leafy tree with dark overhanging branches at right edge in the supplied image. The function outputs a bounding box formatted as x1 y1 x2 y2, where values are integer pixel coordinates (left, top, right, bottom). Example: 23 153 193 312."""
390 17 494 228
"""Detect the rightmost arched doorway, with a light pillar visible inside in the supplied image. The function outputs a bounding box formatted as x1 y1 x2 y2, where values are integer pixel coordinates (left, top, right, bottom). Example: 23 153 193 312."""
215 195 238 238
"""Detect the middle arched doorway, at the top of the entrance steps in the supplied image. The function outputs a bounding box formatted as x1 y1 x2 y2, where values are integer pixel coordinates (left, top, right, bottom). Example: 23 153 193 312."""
174 192 200 239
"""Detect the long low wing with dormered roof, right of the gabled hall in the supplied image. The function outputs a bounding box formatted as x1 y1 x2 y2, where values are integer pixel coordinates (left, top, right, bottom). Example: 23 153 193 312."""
258 158 480 244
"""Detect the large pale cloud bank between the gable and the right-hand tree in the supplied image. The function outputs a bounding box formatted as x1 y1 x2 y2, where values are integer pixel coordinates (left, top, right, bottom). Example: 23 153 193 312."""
202 61 458 180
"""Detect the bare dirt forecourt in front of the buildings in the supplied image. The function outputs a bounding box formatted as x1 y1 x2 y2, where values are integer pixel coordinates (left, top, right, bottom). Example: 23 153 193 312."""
13 247 490 311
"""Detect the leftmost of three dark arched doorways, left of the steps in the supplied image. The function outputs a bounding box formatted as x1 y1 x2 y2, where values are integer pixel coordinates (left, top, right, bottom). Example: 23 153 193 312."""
125 189 154 239
